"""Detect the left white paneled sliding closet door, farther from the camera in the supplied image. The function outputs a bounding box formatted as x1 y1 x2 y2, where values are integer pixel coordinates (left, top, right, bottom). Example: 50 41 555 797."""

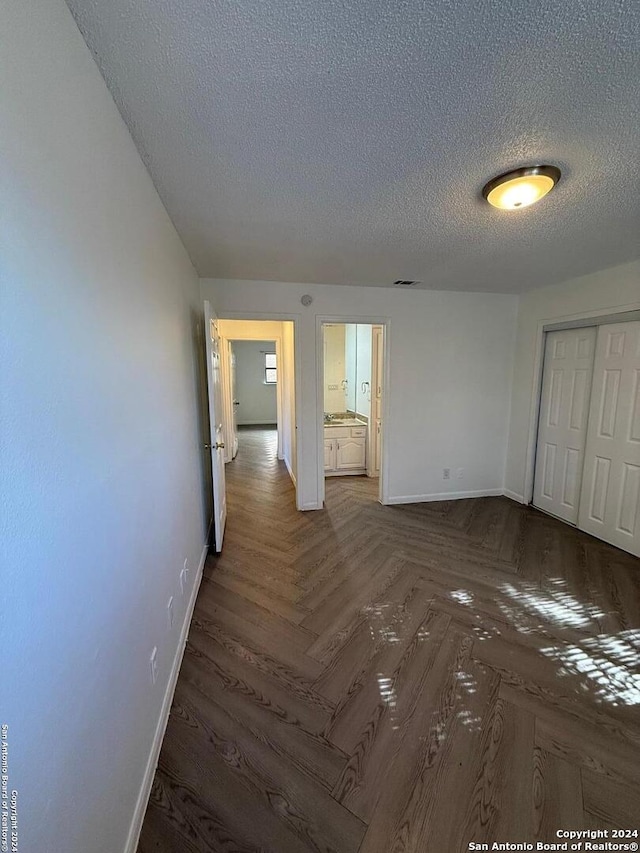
533 326 596 524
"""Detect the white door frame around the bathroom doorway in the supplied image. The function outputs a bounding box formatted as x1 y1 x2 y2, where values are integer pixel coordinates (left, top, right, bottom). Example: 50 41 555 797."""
316 314 391 508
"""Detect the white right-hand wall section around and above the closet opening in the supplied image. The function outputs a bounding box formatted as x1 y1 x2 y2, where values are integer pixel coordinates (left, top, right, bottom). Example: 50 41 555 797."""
505 261 640 500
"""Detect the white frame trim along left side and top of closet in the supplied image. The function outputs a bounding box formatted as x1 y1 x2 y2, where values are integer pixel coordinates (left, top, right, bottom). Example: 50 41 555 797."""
524 302 640 505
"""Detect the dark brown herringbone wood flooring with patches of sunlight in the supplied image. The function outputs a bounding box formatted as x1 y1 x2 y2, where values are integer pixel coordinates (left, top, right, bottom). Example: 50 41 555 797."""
139 430 640 853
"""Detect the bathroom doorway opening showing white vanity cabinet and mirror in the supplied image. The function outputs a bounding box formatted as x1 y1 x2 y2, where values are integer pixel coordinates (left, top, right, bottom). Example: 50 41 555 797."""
318 319 385 502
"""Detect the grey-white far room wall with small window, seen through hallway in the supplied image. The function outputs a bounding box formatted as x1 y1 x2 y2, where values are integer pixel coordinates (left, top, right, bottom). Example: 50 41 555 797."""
233 341 277 424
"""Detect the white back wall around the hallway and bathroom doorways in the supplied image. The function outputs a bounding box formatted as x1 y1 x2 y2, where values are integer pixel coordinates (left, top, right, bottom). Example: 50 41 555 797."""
201 279 517 509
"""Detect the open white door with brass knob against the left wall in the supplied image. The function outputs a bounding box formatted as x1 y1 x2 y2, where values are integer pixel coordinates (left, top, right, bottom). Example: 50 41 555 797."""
204 302 227 552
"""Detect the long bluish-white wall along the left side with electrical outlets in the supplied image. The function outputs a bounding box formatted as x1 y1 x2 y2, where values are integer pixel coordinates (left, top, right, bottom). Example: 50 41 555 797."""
0 0 207 853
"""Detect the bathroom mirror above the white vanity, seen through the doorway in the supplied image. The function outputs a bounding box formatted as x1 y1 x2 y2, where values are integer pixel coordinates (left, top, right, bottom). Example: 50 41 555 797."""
323 323 372 418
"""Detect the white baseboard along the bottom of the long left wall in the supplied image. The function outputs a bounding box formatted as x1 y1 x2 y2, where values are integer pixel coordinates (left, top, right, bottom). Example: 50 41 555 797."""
124 531 211 853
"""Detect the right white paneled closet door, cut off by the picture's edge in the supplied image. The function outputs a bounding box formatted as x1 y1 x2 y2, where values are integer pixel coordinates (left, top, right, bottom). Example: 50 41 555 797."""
579 321 640 556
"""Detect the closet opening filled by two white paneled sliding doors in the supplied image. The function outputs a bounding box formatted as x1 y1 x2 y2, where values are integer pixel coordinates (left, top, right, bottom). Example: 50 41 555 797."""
533 320 640 556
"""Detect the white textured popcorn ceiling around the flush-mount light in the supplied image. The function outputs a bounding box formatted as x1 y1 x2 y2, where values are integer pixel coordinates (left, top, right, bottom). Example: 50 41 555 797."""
68 0 640 292
